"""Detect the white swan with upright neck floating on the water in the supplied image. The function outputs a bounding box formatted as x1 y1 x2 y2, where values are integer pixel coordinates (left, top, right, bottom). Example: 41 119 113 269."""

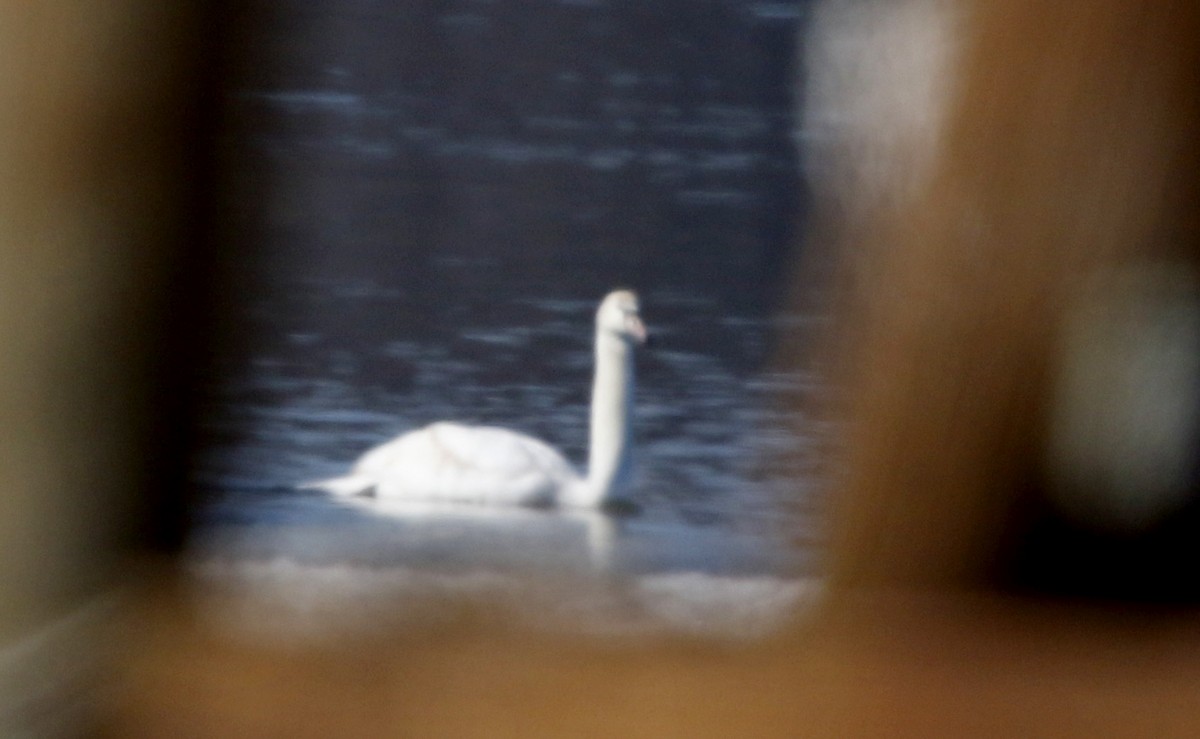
301 290 646 507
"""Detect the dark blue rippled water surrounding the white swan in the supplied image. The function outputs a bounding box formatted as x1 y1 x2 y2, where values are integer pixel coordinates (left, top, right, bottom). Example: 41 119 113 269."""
189 0 815 633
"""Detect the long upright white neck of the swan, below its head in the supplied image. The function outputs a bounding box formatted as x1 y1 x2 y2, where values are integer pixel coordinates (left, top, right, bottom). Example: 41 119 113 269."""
576 332 634 505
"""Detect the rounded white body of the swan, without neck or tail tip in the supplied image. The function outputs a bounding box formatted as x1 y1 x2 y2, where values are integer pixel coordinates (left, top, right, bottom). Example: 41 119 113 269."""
346 422 580 505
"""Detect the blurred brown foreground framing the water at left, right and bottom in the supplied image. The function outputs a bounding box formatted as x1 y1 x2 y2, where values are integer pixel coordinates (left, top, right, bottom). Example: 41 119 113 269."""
0 0 1200 737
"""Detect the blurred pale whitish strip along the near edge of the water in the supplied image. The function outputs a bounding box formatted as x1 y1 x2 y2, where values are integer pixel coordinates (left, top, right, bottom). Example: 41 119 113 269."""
192 558 821 642
